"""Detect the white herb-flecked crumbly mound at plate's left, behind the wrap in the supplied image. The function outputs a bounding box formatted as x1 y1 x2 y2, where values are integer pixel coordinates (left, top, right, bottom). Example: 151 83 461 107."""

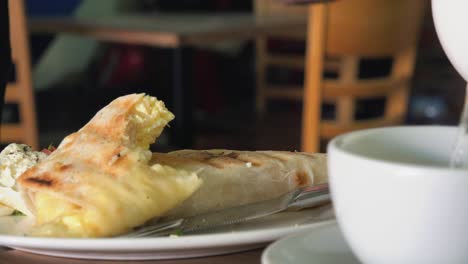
0 143 47 216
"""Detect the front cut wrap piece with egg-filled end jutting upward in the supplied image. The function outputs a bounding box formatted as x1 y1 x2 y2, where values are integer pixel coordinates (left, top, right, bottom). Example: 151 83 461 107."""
18 94 201 237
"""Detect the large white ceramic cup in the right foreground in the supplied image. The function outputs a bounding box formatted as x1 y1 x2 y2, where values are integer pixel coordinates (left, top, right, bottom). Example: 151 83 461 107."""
328 126 468 264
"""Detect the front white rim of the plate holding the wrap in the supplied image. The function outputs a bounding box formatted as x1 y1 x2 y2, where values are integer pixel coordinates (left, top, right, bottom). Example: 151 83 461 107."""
0 218 336 252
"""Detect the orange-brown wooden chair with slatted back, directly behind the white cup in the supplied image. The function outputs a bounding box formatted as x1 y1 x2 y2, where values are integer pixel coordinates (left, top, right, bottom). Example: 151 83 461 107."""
302 0 425 152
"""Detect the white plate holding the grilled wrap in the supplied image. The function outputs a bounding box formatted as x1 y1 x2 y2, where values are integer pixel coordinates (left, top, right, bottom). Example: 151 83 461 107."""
0 207 334 260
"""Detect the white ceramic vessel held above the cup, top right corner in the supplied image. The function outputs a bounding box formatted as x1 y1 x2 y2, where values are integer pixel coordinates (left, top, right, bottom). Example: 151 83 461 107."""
432 0 468 81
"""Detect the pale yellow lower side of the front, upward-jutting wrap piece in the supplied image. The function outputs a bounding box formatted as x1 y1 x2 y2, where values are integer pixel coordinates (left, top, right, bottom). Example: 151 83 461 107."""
32 165 201 237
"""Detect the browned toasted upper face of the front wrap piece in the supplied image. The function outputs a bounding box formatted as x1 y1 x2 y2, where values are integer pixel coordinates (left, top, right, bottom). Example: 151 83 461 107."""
18 94 143 192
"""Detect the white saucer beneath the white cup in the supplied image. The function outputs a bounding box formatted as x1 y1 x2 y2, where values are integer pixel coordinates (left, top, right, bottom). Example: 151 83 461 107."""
262 221 360 264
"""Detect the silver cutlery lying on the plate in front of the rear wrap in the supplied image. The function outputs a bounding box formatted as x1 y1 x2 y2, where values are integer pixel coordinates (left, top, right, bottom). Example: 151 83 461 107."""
120 184 330 237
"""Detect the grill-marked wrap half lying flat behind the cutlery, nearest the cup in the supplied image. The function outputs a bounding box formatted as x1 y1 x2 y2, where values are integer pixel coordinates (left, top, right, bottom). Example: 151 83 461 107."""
151 150 327 218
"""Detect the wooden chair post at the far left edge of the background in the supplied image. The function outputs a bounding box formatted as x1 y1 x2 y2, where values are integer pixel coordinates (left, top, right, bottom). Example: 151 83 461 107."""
0 0 39 149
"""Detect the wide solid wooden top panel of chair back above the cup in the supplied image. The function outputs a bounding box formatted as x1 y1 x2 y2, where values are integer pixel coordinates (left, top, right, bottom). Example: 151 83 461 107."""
326 0 426 57
